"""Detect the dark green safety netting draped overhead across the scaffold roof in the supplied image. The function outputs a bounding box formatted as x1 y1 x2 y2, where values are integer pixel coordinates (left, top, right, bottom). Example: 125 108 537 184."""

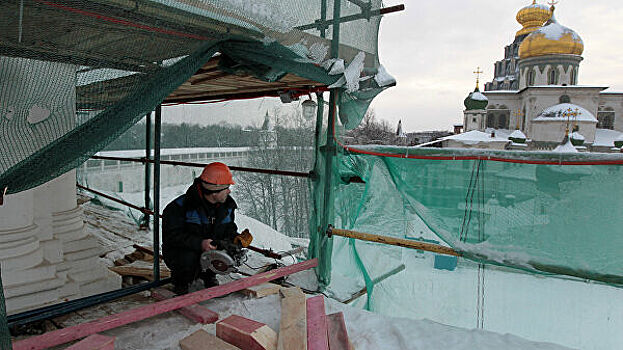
0 0 384 193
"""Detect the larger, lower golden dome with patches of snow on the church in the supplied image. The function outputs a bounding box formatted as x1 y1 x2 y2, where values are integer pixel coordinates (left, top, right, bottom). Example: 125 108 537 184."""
519 10 584 59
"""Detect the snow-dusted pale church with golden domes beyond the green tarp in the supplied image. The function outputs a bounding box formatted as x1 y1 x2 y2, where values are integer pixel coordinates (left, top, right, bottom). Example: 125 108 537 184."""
448 0 623 152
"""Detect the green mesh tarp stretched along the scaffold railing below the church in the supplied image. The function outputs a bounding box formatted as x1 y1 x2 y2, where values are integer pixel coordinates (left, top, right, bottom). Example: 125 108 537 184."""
310 142 623 285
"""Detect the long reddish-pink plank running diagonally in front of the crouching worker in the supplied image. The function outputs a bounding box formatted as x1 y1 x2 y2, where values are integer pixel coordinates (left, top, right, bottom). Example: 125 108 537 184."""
13 259 318 350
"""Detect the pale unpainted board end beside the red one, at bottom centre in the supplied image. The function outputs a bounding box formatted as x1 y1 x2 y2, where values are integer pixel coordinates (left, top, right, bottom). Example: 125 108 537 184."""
277 287 307 350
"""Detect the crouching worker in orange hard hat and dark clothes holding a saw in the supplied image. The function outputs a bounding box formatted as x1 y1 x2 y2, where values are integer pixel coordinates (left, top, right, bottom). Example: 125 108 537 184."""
162 162 241 295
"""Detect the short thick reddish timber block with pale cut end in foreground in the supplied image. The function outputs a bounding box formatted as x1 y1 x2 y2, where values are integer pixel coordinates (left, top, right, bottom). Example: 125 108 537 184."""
216 315 277 350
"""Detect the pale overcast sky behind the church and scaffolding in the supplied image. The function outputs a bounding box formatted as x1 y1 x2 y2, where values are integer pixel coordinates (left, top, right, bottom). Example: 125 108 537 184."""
163 0 623 132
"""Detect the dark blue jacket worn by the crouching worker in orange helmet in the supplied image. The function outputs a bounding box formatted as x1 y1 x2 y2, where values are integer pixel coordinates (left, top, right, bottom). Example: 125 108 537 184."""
162 180 238 254
